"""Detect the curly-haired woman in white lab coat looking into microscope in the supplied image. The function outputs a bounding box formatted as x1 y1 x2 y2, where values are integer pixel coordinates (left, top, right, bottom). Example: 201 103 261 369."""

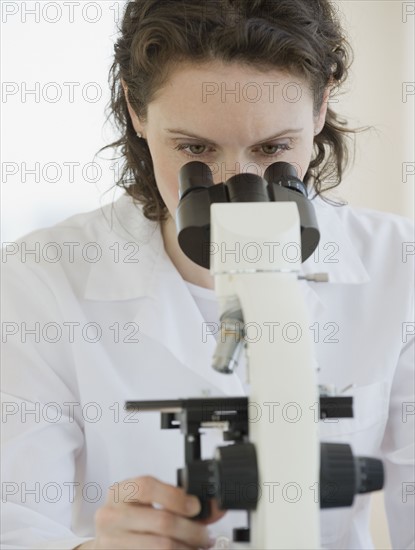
3 0 413 549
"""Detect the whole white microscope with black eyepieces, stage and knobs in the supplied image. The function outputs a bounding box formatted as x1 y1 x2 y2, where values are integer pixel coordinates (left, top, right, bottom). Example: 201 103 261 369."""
126 162 384 550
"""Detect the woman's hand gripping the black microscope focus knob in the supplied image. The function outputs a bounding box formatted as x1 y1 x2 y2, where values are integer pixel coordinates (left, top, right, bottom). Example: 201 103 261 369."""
73 476 226 550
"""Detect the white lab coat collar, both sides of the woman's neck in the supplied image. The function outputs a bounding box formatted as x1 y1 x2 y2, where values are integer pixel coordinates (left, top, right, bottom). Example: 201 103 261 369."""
84 195 370 301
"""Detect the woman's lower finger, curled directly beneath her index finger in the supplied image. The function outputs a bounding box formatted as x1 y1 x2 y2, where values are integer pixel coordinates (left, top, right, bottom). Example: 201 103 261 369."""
101 503 211 548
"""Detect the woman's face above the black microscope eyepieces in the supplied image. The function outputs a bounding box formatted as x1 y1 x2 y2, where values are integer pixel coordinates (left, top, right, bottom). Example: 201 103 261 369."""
129 62 327 218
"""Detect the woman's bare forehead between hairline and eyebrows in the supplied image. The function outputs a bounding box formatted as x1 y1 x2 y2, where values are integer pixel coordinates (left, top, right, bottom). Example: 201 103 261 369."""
148 61 312 125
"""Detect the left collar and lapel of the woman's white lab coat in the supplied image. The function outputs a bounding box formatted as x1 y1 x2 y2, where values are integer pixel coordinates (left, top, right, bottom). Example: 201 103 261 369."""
83 195 245 395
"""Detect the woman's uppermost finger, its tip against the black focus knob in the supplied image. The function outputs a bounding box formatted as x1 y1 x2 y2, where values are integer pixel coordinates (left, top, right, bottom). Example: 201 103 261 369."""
107 476 201 516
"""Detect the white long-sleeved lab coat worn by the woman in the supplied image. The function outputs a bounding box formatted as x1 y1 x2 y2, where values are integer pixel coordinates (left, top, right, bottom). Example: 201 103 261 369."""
2 195 414 549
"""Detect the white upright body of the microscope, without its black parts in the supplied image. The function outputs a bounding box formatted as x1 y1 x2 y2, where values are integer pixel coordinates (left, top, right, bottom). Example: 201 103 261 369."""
211 202 320 550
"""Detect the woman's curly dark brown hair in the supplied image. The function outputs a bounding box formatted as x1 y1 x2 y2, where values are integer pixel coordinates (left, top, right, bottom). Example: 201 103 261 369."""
99 0 357 221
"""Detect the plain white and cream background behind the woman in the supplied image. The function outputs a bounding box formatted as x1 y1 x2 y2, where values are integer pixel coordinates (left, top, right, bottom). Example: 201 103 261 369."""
1 0 415 550
